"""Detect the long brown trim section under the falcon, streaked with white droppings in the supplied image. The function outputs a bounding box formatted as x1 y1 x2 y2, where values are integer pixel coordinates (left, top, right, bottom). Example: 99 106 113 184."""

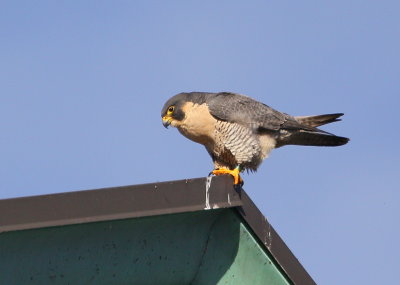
0 177 242 233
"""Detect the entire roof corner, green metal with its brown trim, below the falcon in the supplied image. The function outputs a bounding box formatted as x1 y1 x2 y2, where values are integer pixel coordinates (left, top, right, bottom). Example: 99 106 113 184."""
0 177 315 285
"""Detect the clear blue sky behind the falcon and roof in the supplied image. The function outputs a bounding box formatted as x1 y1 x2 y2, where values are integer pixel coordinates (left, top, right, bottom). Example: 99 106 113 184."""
0 0 400 284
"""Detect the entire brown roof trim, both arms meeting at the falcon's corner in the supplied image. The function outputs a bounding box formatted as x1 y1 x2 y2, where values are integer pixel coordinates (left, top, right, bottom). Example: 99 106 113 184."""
0 176 315 284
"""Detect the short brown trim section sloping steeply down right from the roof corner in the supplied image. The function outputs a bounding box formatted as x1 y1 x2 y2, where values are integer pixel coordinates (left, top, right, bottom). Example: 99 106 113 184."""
237 187 316 285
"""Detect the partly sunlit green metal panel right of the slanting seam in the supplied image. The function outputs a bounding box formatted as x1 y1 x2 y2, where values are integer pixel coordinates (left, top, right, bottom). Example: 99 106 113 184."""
189 210 290 285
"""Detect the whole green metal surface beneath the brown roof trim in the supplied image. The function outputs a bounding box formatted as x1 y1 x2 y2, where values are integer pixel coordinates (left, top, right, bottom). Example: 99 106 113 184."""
0 209 288 285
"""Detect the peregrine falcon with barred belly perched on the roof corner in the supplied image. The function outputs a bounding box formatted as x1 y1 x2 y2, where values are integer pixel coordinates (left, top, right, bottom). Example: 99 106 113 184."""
161 92 349 184
